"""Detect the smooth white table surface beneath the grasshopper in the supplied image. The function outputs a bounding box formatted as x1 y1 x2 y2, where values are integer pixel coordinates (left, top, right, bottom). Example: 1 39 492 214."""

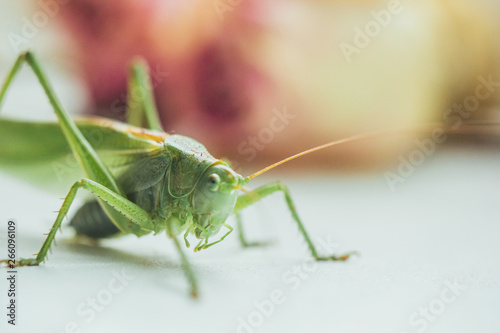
0 149 500 333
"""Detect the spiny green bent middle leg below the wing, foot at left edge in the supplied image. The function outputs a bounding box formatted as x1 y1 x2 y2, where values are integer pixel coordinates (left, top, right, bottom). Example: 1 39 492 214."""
0 179 155 266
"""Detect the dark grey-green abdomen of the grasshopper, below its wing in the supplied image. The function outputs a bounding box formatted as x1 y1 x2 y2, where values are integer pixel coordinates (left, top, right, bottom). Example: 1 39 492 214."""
69 201 120 238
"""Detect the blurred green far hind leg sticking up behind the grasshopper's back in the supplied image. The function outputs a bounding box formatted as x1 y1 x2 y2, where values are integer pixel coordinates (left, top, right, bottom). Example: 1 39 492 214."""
127 59 163 131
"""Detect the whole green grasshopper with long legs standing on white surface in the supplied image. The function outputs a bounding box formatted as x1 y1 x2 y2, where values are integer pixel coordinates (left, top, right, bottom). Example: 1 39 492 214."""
0 51 356 297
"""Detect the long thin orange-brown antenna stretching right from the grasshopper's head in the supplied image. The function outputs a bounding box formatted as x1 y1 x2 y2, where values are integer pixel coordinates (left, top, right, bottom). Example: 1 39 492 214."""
245 122 500 181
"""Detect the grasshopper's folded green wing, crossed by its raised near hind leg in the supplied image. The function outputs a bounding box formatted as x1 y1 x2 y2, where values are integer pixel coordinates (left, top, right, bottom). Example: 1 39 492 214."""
0 118 170 192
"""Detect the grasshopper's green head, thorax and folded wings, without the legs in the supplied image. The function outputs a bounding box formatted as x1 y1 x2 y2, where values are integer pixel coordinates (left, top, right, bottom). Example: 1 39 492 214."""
0 117 243 239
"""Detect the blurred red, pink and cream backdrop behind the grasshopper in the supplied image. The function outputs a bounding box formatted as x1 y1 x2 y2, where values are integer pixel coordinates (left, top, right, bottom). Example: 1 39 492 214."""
0 0 500 171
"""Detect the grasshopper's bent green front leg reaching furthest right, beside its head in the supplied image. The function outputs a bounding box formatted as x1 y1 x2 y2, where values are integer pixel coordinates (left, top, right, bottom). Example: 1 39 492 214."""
234 182 350 260
